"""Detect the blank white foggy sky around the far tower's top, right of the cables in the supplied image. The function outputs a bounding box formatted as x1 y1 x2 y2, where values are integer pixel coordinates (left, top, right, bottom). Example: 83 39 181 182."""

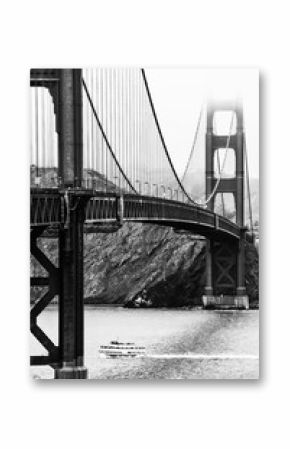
145 68 259 178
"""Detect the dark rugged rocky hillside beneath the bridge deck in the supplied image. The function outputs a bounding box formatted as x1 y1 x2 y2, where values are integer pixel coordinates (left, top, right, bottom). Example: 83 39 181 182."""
32 223 258 307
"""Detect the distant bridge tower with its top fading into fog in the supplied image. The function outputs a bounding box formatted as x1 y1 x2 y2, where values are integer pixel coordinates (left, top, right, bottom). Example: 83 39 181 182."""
203 102 249 308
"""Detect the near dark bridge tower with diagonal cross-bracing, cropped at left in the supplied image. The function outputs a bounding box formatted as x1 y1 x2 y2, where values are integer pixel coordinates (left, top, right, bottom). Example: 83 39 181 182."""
31 69 90 379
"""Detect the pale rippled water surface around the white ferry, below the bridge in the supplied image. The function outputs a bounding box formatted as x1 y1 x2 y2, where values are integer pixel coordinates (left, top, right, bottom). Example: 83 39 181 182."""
31 306 259 379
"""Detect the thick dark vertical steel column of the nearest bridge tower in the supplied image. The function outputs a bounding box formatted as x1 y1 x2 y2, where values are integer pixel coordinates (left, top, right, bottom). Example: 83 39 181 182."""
55 69 87 379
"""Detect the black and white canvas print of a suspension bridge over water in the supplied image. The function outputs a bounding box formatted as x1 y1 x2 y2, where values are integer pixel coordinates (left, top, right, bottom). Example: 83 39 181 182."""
29 67 259 381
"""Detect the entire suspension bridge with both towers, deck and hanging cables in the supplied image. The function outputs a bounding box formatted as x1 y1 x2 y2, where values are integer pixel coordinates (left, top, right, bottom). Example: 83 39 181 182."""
30 68 252 378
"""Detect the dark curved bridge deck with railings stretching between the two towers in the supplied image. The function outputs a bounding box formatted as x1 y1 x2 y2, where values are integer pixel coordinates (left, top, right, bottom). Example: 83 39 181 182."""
30 189 244 240
